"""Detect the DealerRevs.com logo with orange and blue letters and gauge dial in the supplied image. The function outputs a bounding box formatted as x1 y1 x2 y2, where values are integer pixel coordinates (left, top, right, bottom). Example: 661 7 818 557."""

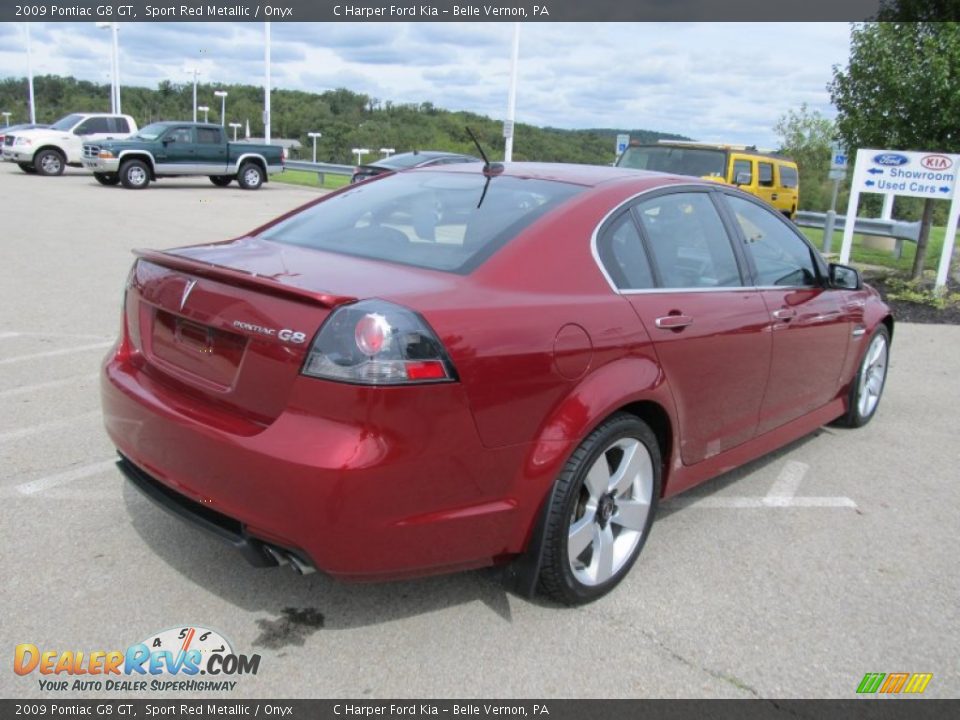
13 626 260 692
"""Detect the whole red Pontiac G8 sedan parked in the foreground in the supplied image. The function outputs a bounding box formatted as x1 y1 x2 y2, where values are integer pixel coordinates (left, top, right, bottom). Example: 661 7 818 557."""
102 163 893 604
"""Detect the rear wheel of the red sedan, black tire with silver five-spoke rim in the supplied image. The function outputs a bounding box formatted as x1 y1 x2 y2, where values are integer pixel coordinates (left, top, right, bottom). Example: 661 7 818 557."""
539 413 661 605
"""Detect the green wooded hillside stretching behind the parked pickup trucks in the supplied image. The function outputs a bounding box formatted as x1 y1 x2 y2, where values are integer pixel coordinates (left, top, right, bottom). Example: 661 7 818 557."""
0 75 682 164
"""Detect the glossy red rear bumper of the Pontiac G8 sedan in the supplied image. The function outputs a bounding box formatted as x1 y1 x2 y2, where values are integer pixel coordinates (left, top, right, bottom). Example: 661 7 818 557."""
107 354 542 580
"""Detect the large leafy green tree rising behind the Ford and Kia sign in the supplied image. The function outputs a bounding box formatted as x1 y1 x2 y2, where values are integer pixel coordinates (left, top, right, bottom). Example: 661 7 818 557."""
828 21 960 279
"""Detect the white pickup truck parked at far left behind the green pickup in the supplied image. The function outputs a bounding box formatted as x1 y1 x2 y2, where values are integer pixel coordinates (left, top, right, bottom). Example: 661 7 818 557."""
3 113 137 175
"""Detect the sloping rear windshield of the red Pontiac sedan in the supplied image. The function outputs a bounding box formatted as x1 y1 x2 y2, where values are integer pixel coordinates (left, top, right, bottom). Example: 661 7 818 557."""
262 171 584 273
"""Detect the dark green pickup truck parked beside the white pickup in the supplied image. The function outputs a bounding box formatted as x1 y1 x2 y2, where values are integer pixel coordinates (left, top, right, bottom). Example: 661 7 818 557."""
83 122 284 190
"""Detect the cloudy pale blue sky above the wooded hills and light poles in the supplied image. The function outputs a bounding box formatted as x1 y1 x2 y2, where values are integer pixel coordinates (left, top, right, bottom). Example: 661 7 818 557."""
0 22 849 146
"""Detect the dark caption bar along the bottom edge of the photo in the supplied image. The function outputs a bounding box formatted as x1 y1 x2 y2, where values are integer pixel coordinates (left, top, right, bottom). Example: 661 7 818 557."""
0 698 960 720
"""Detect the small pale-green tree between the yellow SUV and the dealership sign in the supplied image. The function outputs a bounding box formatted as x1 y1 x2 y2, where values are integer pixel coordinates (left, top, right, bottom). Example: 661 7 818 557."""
773 103 837 210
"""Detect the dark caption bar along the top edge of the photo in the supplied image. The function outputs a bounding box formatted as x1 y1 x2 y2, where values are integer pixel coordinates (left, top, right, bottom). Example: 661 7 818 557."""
0 0 932 22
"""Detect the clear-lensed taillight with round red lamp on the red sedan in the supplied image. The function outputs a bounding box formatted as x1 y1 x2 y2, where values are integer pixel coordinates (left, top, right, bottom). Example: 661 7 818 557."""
303 300 456 385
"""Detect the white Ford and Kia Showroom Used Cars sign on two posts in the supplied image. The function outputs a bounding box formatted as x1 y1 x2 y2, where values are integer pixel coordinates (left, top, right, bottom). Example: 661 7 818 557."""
840 149 960 288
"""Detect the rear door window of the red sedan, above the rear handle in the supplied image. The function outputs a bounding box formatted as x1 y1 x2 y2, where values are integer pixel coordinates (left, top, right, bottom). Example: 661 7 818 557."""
636 193 743 288
